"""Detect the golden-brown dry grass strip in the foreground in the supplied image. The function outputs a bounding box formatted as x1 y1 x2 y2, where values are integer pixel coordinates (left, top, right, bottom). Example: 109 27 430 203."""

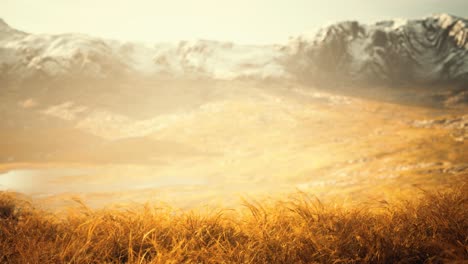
0 187 468 263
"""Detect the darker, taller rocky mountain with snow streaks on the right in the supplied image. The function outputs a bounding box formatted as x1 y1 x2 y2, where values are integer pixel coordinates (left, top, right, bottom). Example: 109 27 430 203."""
288 14 468 84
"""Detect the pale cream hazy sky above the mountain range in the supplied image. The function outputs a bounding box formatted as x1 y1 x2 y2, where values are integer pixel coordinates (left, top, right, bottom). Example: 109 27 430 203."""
0 0 468 43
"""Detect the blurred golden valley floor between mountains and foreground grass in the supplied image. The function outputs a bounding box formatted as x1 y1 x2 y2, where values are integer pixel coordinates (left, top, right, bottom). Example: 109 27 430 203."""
0 82 468 208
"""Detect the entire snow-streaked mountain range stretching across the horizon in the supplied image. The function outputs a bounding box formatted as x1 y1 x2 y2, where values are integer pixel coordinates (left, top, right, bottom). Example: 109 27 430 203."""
0 14 468 84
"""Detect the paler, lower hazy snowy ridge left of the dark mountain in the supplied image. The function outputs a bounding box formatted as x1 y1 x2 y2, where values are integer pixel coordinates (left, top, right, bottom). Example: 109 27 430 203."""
0 17 286 79
